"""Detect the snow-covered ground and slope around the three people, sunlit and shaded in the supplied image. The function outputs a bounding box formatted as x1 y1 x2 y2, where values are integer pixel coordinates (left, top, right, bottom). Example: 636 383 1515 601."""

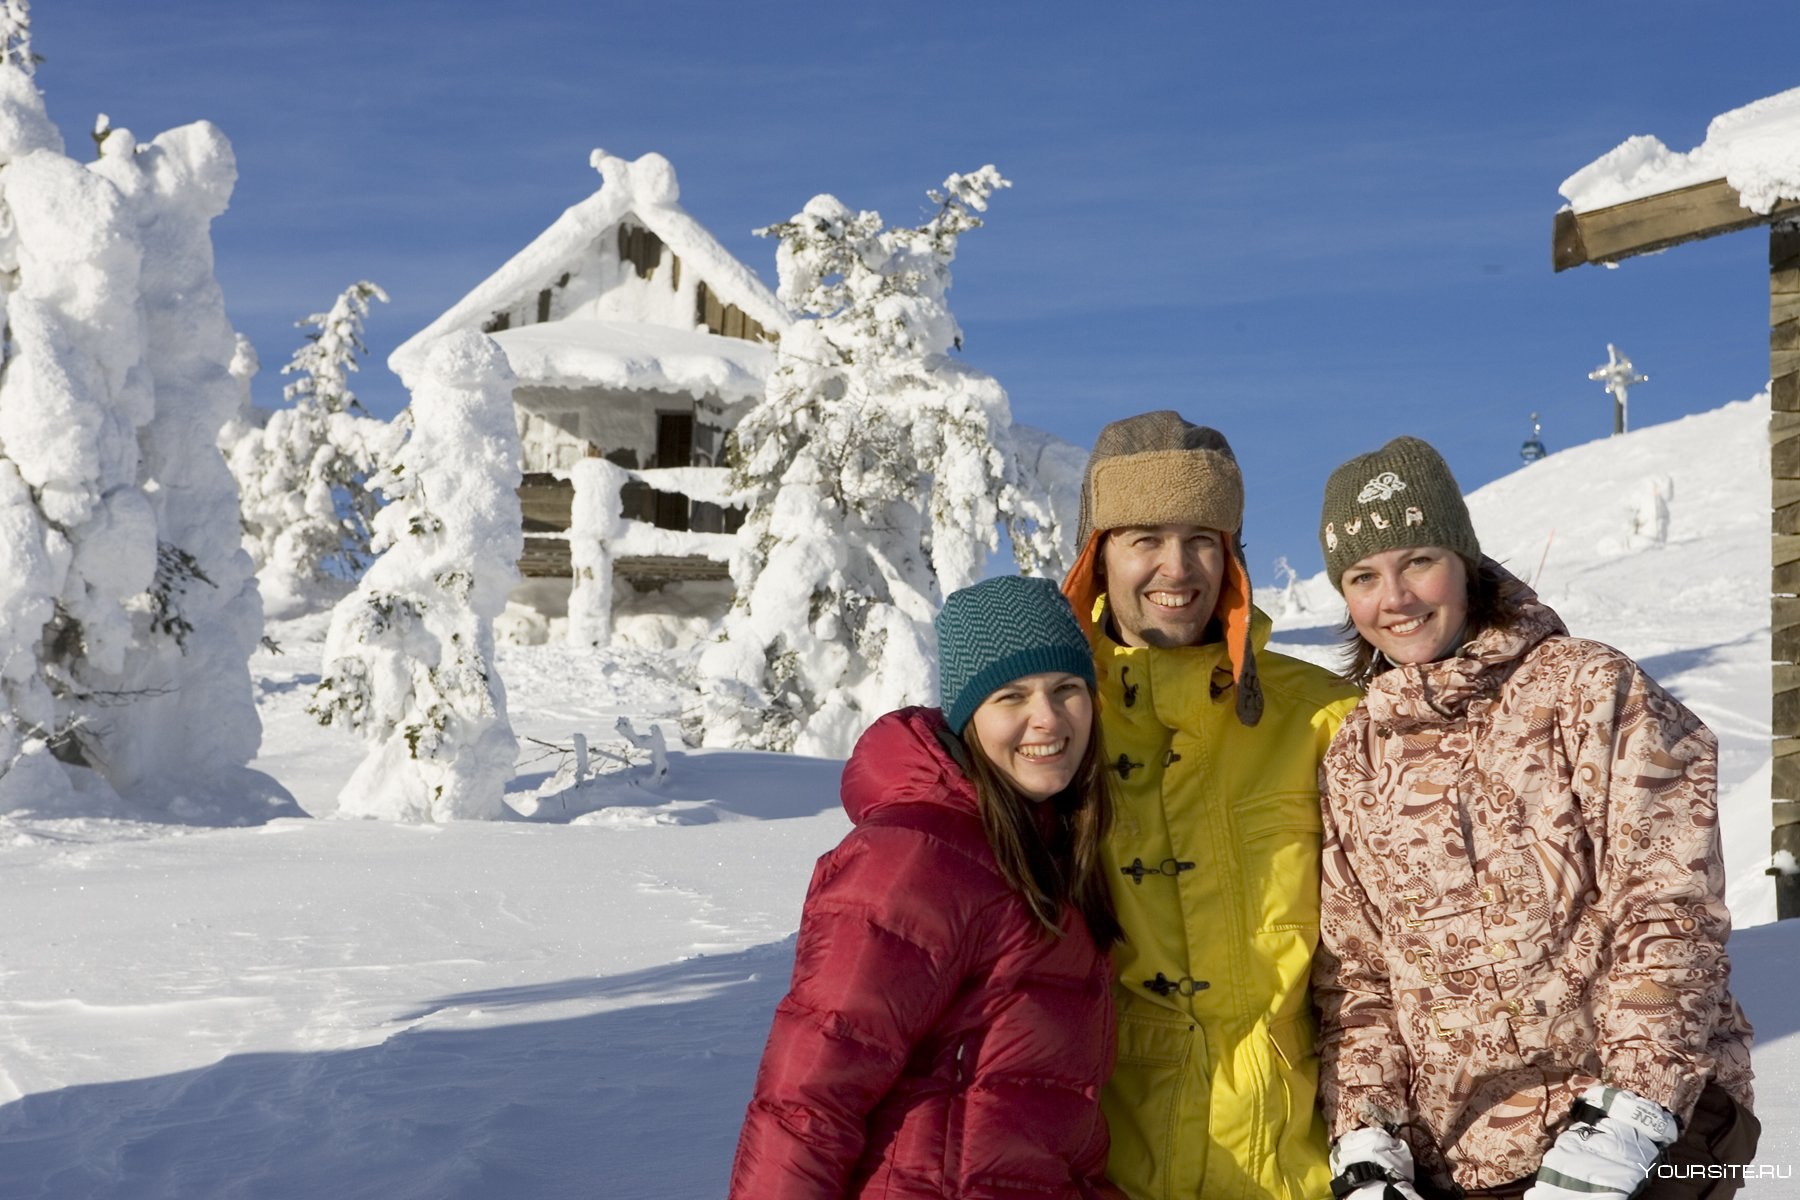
0 401 1800 1200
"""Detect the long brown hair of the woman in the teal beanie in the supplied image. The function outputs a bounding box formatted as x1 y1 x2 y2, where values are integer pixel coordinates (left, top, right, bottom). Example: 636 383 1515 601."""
961 687 1125 950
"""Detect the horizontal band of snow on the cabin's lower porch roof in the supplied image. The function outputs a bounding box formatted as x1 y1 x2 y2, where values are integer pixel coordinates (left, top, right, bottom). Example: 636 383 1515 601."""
496 320 774 401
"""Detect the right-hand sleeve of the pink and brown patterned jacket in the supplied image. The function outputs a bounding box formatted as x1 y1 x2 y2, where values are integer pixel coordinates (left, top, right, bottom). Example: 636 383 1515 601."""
1564 653 1732 1121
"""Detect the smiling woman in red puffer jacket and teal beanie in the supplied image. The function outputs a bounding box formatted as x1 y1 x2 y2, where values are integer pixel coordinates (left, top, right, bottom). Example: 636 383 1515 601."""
731 578 1120 1200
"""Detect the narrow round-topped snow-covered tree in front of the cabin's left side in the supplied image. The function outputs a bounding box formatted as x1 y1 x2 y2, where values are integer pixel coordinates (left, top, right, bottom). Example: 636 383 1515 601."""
310 331 524 822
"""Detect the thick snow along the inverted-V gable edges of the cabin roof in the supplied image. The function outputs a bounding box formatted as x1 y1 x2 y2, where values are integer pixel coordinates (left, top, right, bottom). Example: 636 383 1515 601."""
387 149 794 385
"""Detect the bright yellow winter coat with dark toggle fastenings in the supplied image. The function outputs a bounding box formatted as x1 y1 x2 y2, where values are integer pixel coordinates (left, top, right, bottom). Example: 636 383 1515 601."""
1093 599 1357 1200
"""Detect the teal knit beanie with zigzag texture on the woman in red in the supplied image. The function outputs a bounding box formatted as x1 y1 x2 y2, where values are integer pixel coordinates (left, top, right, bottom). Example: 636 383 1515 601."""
936 576 1094 734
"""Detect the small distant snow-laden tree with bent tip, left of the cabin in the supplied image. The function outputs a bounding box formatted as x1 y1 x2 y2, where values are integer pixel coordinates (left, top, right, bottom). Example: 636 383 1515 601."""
229 281 391 615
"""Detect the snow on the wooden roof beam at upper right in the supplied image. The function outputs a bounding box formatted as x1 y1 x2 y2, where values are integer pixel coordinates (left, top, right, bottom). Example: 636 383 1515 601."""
1557 88 1800 212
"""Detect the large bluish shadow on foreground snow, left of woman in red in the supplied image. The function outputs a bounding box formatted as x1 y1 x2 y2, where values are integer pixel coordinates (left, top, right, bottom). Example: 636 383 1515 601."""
0 939 794 1200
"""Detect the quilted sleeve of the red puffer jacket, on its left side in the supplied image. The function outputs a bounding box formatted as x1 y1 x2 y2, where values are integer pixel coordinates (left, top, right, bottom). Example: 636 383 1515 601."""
731 826 995 1200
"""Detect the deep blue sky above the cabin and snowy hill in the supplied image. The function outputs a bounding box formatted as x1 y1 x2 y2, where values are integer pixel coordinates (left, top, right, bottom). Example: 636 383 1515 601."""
32 0 1800 583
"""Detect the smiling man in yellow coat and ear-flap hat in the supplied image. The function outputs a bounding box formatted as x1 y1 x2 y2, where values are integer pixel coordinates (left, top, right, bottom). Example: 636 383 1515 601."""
1064 412 1357 1200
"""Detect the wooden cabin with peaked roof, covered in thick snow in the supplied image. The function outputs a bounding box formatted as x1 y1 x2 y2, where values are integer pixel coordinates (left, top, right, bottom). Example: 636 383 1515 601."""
387 149 790 597
